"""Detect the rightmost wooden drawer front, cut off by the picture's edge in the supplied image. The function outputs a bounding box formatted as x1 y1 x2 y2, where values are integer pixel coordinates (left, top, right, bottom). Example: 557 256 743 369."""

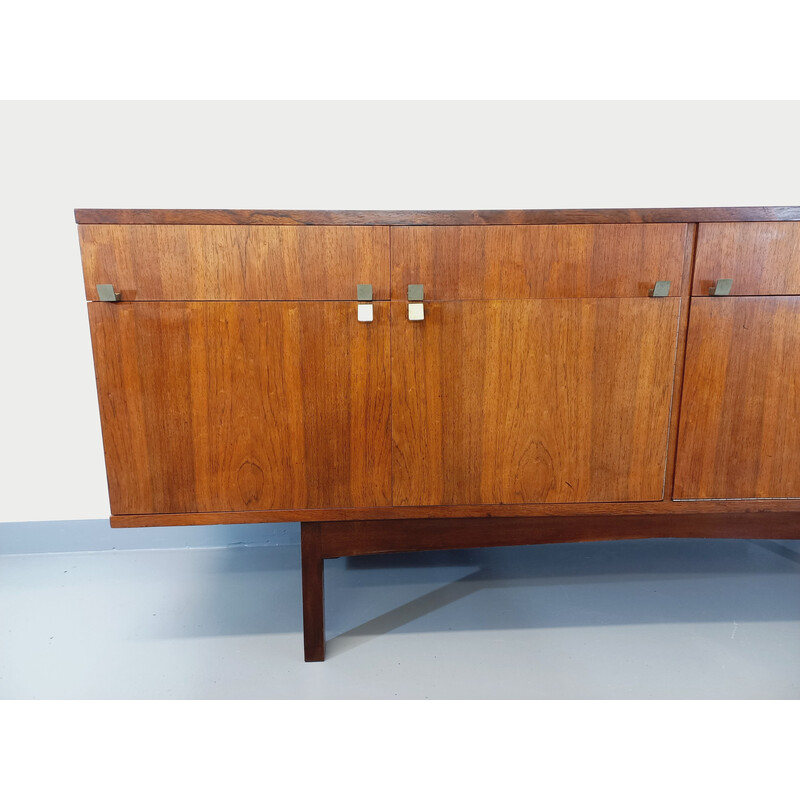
692 222 800 295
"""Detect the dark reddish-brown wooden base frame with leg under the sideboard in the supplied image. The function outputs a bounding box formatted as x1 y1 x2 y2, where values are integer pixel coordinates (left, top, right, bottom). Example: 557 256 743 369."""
300 511 800 661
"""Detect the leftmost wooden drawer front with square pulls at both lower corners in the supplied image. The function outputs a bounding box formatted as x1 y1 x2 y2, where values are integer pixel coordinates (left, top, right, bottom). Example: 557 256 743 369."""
78 225 389 301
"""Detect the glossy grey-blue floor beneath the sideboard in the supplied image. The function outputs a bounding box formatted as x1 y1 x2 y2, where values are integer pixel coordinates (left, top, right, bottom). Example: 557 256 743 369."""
0 539 800 699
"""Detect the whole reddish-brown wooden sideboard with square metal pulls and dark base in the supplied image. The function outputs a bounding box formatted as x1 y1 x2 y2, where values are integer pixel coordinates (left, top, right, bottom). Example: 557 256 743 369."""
75 207 800 661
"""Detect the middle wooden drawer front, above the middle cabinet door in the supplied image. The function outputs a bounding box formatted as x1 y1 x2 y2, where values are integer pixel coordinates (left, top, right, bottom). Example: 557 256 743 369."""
392 224 688 300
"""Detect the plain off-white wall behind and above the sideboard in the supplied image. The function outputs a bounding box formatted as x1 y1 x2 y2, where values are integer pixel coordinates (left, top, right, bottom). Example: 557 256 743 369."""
0 102 800 522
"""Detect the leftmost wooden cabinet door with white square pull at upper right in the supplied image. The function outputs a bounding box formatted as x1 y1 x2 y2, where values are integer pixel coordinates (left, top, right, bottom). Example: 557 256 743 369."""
89 302 391 514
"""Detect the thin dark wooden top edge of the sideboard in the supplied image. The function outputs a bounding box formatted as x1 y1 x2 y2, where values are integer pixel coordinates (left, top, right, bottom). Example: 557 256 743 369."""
75 206 800 225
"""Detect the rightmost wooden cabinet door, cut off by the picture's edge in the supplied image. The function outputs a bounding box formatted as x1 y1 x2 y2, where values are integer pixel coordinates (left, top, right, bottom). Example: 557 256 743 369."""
674 297 800 499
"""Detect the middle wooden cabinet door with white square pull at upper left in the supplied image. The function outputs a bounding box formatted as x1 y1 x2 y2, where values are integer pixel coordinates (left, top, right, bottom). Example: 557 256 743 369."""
391 298 681 505
